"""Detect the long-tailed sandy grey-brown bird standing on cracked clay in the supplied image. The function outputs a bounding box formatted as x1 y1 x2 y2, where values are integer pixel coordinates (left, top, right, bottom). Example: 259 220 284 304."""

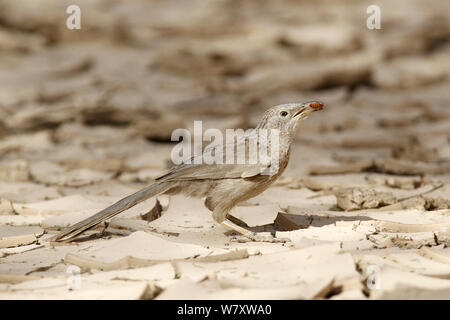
51 101 324 242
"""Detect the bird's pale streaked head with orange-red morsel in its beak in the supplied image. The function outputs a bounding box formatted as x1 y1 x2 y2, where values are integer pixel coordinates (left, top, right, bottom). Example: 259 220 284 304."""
258 101 324 135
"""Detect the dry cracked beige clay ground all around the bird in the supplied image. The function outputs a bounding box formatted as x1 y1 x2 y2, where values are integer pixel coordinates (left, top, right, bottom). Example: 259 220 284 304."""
0 1 450 299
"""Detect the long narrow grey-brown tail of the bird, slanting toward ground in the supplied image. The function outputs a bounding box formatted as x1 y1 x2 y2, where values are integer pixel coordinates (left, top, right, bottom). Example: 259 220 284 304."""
50 181 173 241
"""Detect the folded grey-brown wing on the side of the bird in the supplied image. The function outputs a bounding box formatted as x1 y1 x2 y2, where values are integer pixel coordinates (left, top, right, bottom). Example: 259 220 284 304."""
156 136 270 181
